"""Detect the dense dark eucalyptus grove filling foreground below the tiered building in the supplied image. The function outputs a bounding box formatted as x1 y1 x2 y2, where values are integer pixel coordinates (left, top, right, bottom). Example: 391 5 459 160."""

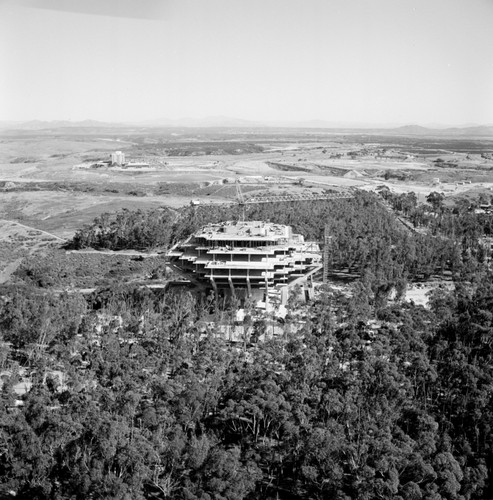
0 281 493 499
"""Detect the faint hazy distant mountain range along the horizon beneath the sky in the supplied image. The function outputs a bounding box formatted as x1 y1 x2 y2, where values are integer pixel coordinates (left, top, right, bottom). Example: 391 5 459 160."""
0 116 493 137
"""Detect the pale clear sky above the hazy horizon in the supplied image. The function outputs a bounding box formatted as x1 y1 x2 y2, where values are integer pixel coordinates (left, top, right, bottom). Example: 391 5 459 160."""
0 0 493 126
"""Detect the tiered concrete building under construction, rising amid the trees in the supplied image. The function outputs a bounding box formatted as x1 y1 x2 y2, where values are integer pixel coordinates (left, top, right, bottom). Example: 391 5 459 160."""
168 221 322 304
